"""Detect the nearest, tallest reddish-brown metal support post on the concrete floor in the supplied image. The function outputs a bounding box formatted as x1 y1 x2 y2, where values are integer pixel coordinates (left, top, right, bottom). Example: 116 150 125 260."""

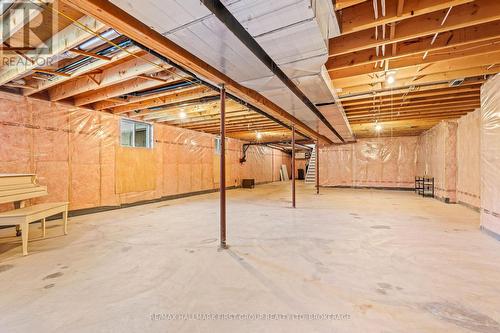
220 84 227 249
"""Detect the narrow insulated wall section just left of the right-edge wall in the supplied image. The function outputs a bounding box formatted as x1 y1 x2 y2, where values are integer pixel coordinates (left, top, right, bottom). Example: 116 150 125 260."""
456 109 481 208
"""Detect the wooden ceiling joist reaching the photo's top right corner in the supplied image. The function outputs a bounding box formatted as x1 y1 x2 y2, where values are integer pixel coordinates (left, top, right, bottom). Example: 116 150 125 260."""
329 0 500 56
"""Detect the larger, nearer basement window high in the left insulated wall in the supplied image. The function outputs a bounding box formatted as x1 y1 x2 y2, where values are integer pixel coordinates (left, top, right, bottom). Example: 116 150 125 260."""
120 119 153 148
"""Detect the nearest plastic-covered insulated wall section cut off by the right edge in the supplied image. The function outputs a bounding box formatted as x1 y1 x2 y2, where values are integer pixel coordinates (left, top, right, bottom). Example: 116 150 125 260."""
481 74 500 237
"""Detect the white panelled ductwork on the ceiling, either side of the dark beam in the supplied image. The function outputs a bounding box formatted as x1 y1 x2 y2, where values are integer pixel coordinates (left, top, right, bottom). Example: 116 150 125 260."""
111 0 352 142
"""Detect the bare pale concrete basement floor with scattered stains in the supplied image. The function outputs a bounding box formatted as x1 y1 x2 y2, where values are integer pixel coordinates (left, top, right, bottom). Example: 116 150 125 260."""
0 183 500 333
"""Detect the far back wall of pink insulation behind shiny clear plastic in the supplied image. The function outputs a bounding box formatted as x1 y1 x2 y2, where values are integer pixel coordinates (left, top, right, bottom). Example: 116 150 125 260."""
319 137 417 188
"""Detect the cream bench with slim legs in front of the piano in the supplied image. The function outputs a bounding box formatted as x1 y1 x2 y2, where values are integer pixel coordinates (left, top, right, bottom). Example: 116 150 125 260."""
0 202 68 255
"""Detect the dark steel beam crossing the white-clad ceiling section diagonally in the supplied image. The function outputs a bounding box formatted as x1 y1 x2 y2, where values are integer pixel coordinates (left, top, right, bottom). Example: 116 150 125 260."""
201 0 345 143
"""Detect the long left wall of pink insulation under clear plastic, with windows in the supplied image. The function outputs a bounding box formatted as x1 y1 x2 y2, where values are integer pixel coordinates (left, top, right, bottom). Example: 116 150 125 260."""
0 93 290 210
